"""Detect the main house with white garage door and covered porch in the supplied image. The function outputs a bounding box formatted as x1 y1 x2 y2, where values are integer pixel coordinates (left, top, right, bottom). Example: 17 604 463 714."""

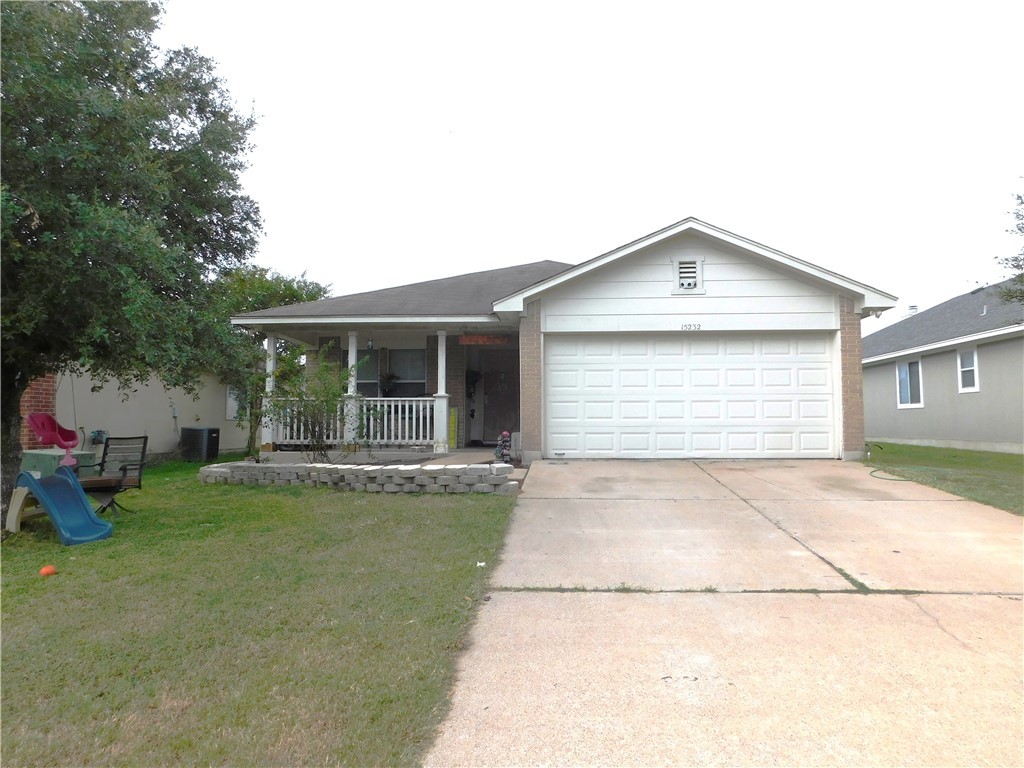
231 218 896 462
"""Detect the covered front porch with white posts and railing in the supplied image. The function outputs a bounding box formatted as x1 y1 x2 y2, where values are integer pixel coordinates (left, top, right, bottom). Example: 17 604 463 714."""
261 327 519 462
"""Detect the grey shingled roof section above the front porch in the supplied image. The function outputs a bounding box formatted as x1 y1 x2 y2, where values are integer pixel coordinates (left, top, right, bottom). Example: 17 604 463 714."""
231 261 570 325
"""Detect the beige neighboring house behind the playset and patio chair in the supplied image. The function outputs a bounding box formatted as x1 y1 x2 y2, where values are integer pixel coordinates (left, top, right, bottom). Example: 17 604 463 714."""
22 374 246 455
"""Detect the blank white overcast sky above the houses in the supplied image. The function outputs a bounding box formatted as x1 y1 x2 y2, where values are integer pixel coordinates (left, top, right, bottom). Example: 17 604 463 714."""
156 0 1024 333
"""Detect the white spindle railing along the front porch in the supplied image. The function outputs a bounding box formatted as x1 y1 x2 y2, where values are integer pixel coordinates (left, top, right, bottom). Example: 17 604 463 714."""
271 397 434 446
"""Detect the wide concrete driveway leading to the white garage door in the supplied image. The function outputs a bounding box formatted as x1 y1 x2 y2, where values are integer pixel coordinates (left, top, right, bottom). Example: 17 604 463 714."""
426 461 1024 766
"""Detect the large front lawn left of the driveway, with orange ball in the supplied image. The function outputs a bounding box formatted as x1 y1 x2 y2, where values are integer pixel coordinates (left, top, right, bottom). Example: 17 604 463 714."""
0 463 514 766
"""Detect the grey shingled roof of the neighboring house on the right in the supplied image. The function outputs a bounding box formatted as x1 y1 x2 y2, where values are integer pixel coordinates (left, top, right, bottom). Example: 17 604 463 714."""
861 279 1024 361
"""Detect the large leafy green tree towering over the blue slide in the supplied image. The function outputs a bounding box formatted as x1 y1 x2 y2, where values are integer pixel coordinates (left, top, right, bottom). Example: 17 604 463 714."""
0 2 261 518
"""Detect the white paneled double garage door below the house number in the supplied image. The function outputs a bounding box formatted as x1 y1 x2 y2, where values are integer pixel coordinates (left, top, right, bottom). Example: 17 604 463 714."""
544 333 837 459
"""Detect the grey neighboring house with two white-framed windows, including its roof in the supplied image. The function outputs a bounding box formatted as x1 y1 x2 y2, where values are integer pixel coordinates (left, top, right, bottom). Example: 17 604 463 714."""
862 281 1024 454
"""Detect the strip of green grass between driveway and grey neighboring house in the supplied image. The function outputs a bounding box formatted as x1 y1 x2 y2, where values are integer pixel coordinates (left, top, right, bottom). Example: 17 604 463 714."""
865 442 1024 515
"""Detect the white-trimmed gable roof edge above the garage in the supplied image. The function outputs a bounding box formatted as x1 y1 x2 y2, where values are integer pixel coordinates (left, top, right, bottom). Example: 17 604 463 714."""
495 216 896 315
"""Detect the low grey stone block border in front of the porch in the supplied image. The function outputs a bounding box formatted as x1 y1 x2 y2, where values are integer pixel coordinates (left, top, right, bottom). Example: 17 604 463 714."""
199 462 519 496
